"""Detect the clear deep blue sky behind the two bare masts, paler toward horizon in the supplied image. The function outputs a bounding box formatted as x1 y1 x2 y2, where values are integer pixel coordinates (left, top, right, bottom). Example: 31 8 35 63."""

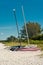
0 0 43 40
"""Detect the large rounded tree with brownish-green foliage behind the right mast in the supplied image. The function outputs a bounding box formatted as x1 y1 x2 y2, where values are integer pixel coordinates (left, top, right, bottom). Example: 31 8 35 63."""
21 22 41 38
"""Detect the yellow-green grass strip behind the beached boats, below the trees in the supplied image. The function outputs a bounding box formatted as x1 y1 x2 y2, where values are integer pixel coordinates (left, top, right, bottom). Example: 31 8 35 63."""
4 40 43 50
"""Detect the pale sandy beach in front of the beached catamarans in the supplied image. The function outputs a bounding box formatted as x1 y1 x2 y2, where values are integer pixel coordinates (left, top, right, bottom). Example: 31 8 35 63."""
0 43 43 65
